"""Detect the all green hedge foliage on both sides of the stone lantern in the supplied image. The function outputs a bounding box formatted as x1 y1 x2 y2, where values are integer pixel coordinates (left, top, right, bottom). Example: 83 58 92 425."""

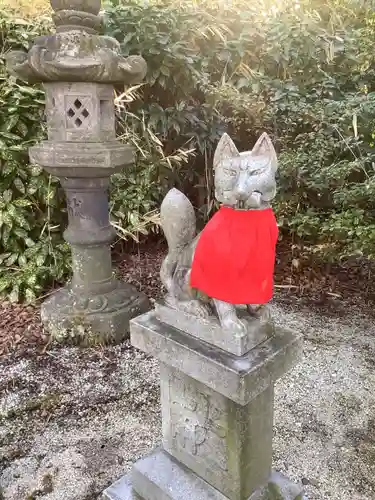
0 0 375 300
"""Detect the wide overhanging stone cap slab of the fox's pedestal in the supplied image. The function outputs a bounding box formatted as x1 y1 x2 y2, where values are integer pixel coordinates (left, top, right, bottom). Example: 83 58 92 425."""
131 312 302 405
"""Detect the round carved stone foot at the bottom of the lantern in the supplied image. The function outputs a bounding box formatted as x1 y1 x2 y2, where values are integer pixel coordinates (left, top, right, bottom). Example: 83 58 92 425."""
41 281 151 345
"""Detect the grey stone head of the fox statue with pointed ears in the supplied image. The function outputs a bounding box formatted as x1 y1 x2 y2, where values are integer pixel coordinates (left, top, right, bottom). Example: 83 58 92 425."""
214 133 277 210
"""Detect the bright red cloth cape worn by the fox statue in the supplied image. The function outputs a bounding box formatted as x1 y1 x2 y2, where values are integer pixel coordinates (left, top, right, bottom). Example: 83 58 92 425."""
190 207 278 304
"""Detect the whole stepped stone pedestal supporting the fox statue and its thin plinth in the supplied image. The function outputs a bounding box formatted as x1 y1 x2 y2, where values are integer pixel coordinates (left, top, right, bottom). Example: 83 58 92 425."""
104 309 303 500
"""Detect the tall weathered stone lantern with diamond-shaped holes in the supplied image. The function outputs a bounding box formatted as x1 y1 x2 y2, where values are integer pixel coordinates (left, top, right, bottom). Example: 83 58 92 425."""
8 0 149 342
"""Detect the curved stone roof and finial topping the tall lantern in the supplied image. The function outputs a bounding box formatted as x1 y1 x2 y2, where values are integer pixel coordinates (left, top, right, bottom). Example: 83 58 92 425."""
7 0 147 85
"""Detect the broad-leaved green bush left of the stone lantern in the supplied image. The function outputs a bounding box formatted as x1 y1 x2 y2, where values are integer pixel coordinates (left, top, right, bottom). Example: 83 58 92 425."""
0 16 68 301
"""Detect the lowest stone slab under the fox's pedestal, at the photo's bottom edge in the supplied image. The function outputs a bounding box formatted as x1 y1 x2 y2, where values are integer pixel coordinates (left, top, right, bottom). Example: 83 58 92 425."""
102 450 307 500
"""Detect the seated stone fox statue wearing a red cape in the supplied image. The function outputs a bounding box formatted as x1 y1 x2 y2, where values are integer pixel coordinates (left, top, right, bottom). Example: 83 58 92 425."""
160 133 278 334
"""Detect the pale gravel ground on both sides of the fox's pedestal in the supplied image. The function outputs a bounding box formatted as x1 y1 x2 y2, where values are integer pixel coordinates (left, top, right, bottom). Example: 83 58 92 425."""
0 302 375 500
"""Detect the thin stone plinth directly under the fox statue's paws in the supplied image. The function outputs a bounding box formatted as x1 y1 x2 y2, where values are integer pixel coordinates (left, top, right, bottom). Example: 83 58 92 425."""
155 303 274 356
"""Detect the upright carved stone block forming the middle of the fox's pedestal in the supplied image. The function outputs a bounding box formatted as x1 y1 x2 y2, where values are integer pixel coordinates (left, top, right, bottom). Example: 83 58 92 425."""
161 364 273 500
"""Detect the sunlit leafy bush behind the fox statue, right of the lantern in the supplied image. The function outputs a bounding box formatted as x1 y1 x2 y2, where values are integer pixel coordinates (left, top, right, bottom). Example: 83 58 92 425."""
107 0 375 259
